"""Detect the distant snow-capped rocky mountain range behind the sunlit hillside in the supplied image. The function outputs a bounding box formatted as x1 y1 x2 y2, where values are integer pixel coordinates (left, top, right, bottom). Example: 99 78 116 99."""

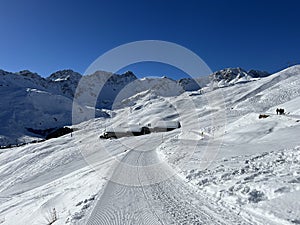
0 68 267 146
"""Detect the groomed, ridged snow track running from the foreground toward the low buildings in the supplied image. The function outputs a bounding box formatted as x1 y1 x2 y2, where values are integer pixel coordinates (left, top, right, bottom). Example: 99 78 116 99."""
87 138 250 225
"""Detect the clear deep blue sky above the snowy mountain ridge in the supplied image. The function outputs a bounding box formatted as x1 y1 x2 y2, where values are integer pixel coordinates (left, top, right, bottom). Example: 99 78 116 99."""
0 0 300 76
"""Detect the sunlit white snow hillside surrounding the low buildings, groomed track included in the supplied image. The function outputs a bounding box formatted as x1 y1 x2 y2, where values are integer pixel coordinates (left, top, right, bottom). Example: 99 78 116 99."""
0 66 300 225
